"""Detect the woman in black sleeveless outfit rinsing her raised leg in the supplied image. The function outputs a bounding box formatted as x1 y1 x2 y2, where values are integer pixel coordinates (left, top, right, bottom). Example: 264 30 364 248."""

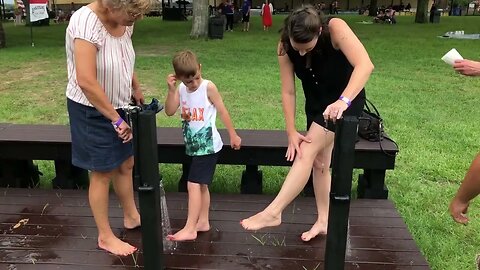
241 6 374 241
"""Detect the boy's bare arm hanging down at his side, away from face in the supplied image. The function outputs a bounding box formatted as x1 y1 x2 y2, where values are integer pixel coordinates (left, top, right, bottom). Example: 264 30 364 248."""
207 82 242 150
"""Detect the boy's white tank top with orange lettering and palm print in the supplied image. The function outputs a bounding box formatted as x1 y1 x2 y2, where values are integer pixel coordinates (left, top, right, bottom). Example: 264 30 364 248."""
179 80 223 156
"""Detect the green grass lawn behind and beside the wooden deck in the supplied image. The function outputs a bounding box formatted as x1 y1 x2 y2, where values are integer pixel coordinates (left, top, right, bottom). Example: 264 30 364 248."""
0 16 480 270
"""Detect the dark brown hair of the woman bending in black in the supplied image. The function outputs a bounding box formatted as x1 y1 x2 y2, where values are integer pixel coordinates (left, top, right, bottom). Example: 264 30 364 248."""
278 5 330 55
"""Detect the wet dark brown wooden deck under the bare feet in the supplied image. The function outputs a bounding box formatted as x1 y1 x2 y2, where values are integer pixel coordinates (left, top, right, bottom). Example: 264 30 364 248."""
0 188 430 270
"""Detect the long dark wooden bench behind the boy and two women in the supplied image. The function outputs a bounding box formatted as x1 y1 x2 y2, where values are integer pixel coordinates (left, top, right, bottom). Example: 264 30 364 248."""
0 124 398 199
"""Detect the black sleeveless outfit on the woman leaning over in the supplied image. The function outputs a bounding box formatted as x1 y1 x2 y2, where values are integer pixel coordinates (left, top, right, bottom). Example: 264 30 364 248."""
287 33 365 131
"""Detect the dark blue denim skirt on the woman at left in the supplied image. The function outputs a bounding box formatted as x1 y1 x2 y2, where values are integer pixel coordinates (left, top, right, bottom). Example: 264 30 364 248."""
67 99 133 172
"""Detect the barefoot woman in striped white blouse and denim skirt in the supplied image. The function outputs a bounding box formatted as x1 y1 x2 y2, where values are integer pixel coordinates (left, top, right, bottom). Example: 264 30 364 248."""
65 0 152 256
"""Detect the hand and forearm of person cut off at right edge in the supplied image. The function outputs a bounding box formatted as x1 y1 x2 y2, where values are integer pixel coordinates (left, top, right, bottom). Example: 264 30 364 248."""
449 59 480 224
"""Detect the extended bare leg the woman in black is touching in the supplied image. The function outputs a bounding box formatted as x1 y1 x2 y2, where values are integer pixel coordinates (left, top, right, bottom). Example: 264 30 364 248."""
241 123 327 230
